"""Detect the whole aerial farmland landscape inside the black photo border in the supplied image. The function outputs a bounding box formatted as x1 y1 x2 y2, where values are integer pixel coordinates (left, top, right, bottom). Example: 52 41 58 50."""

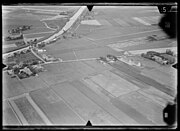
2 6 177 127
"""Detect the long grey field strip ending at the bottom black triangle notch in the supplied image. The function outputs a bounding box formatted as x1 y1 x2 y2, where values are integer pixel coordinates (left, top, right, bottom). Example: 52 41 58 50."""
52 83 126 125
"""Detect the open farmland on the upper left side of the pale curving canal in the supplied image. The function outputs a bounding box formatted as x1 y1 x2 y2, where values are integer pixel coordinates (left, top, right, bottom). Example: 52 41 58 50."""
2 6 78 52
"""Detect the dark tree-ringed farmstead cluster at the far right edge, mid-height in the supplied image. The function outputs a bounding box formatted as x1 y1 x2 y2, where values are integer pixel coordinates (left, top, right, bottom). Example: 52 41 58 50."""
141 50 176 65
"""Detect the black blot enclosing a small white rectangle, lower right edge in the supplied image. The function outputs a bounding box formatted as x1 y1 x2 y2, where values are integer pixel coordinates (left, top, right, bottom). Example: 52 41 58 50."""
163 98 176 126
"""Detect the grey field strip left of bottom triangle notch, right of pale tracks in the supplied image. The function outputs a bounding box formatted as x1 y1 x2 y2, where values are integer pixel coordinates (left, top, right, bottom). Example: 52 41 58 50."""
30 89 85 125
